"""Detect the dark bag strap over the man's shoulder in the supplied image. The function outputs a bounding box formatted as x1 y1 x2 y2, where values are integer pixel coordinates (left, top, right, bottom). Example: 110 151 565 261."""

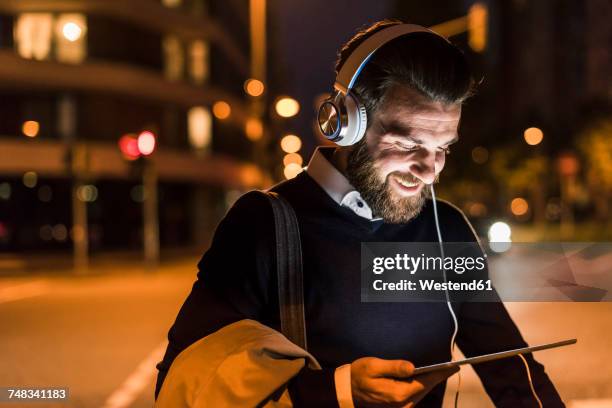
265 191 307 350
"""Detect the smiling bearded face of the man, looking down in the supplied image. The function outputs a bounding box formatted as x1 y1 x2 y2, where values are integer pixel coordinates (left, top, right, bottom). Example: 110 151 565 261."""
347 85 461 223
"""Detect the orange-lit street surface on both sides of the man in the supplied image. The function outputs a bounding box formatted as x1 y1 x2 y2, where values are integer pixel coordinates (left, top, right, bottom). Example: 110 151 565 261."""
0 258 612 408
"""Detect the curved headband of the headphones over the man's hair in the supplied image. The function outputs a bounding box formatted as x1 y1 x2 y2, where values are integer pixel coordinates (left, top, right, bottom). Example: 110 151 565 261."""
334 24 440 95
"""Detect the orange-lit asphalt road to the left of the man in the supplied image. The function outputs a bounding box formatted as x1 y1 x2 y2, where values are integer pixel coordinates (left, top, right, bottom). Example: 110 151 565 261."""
0 260 195 408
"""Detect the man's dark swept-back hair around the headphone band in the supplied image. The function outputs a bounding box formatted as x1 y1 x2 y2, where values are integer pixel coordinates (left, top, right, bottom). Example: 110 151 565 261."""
336 20 474 115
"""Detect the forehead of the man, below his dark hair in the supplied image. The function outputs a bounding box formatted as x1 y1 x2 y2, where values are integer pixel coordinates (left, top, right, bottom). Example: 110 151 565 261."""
375 85 461 129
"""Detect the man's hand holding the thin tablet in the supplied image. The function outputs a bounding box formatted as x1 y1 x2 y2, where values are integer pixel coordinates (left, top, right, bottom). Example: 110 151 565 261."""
351 357 459 407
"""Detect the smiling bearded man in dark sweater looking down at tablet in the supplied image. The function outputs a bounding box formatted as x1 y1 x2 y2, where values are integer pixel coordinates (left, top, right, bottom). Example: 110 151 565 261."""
157 22 563 407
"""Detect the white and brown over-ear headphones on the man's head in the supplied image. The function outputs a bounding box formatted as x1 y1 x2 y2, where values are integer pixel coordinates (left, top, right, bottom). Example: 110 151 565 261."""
317 24 446 146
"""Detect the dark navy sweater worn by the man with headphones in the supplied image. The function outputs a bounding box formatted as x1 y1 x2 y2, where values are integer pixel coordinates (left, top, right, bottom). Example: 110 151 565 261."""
156 172 564 407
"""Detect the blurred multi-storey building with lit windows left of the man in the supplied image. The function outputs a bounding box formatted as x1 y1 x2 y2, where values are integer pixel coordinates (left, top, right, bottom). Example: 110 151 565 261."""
0 0 264 251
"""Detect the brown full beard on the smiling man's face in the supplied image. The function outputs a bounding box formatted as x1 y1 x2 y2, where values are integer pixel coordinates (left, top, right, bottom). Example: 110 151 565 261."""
346 138 431 224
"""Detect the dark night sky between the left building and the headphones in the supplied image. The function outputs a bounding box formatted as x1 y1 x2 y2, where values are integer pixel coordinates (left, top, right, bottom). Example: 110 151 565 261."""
268 0 396 156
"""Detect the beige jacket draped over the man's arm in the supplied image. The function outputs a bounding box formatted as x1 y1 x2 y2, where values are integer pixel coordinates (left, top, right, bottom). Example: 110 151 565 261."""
155 320 321 408
